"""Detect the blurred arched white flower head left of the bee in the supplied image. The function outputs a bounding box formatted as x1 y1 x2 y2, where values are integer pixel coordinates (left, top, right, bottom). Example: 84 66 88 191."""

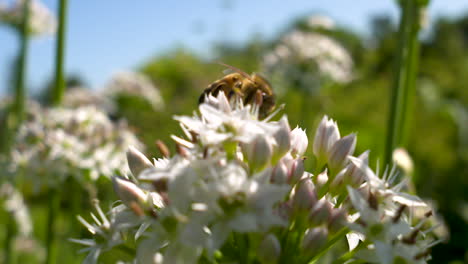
102 72 164 111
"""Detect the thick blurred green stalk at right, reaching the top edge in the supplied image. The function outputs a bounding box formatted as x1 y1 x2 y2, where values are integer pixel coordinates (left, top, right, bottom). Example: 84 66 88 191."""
384 0 420 165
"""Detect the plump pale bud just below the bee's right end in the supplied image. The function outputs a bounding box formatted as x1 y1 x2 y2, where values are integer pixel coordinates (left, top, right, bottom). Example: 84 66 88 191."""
242 135 272 171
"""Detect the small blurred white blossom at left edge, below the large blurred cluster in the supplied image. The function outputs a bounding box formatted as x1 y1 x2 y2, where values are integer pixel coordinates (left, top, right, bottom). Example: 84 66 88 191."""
0 183 33 237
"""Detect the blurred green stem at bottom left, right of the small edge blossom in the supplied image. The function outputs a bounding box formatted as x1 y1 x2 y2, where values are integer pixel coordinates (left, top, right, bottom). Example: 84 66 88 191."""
46 188 60 264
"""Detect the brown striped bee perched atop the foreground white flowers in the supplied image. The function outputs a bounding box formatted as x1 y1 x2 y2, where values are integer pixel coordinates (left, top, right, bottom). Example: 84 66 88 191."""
198 63 275 118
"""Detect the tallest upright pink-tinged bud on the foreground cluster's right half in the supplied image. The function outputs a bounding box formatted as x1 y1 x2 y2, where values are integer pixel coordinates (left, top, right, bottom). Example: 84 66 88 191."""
313 116 340 166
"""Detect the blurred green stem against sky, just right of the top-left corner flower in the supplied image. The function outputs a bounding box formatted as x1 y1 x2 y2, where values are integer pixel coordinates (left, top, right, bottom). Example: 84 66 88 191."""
52 0 68 106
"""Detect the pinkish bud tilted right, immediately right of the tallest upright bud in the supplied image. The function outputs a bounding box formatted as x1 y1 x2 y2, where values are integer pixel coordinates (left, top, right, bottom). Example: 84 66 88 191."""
328 133 356 173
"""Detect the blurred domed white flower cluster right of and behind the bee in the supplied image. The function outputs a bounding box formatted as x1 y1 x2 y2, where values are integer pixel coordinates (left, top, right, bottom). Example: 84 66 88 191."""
263 26 354 93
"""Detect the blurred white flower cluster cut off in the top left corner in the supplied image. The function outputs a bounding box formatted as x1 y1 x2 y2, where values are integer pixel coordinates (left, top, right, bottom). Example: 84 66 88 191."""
0 0 57 35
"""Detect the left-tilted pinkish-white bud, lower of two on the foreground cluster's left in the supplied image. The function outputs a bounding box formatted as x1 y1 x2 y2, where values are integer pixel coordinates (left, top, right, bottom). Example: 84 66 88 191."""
112 177 148 215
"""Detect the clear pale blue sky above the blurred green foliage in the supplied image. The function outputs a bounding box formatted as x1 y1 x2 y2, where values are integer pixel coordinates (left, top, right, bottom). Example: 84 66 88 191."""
0 0 468 94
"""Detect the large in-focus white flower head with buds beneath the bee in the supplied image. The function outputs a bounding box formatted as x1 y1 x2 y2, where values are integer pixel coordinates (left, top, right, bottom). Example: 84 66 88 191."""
73 93 446 263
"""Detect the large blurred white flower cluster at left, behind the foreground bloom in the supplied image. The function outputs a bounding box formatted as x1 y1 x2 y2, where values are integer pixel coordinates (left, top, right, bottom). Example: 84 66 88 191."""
12 104 142 187
